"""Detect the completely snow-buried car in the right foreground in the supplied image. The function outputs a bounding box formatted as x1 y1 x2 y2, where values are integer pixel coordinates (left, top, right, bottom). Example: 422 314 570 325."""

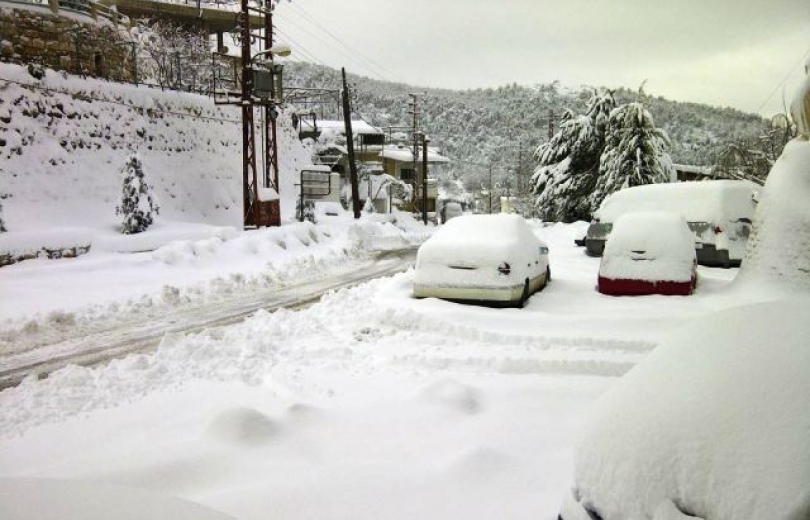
559 296 810 520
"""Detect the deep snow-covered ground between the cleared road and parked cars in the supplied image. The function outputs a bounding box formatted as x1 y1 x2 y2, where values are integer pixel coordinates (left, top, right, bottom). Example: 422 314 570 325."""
0 219 784 519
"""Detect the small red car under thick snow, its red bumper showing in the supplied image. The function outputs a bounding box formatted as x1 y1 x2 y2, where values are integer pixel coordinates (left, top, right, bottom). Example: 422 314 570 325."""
598 211 697 296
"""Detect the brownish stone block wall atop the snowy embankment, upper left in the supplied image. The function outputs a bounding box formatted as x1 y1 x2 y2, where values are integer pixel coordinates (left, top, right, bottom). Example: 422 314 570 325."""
0 0 133 81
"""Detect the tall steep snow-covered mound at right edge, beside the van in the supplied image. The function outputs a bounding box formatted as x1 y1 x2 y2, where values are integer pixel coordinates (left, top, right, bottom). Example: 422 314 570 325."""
741 139 810 290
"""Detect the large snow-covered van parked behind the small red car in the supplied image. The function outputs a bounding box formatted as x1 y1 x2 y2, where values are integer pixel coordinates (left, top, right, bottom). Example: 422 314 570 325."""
585 180 756 267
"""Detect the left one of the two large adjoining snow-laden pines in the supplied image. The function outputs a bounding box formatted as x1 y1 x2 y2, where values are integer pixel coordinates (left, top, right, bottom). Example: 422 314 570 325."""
532 90 616 222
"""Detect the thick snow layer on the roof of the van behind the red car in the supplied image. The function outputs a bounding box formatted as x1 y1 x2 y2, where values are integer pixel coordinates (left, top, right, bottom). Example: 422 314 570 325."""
594 180 756 223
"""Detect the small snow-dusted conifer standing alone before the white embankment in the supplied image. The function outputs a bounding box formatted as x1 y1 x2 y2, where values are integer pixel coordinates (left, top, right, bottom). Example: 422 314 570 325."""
115 155 160 235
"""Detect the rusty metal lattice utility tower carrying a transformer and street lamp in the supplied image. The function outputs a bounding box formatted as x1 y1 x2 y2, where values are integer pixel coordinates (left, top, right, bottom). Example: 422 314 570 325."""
215 0 282 227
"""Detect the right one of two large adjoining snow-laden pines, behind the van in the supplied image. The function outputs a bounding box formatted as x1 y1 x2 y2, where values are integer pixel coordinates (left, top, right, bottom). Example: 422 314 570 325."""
592 102 674 207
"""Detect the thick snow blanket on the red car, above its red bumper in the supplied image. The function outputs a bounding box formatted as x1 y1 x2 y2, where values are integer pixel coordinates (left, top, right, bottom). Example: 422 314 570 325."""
599 211 695 282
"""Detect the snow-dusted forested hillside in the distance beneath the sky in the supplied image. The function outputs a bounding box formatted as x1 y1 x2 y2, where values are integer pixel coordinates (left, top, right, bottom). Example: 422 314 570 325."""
285 62 766 184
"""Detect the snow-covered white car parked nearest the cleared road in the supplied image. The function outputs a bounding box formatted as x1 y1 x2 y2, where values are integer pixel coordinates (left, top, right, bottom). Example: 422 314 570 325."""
413 214 551 306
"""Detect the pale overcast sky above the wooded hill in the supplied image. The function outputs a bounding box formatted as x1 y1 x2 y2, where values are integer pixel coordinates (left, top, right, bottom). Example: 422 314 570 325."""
275 0 810 116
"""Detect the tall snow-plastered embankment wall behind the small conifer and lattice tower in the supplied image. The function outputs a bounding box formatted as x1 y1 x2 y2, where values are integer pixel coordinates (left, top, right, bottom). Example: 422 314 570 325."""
0 64 310 231
